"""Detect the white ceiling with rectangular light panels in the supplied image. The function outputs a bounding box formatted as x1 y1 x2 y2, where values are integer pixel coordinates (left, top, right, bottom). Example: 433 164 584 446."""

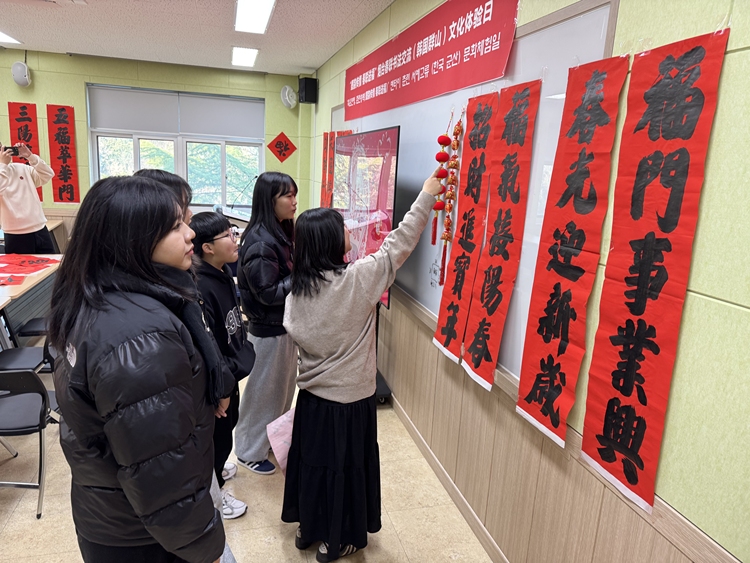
0 0 393 75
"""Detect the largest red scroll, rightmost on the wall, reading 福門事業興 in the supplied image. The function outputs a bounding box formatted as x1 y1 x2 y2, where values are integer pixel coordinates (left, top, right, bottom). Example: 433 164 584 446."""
583 29 729 512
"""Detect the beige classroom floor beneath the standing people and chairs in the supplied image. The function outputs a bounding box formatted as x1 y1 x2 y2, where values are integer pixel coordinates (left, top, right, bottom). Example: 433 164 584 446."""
0 375 490 563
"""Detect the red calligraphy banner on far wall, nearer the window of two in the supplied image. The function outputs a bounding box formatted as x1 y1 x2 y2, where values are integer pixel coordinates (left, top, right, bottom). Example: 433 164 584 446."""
47 104 81 203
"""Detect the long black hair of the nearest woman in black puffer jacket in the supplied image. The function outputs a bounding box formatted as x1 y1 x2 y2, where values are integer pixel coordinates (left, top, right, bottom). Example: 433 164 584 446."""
49 176 190 350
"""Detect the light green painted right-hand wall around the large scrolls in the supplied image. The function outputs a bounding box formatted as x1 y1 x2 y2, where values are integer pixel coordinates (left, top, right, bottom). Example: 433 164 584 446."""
311 0 750 561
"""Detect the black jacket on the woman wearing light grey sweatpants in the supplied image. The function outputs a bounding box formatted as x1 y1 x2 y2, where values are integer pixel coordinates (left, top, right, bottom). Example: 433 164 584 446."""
237 226 292 337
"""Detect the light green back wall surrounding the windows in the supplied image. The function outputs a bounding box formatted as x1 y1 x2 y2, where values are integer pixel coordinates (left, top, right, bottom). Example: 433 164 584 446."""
0 49 312 213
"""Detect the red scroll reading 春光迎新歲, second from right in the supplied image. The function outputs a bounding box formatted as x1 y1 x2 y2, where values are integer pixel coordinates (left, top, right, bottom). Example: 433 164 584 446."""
516 56 628 447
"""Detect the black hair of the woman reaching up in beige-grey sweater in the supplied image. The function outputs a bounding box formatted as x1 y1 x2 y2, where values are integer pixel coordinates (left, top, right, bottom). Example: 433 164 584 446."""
292 207 346 296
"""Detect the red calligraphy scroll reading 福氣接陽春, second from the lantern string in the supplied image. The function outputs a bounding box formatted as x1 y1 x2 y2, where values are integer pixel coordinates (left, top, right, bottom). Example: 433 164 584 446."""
462 80 542 391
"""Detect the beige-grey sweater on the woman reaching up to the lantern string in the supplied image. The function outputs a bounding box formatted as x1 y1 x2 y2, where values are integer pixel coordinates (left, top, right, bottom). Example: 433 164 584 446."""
284 191 435 403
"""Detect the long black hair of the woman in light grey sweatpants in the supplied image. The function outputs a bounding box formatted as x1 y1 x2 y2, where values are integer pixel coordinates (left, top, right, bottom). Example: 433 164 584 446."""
240 172 297 242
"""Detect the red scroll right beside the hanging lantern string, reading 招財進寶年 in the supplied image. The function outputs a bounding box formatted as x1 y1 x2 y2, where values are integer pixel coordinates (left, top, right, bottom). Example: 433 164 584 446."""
432 92 502 362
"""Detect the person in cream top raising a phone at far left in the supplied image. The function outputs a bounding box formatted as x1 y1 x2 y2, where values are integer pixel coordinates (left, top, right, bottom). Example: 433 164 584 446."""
0 143 55 254
